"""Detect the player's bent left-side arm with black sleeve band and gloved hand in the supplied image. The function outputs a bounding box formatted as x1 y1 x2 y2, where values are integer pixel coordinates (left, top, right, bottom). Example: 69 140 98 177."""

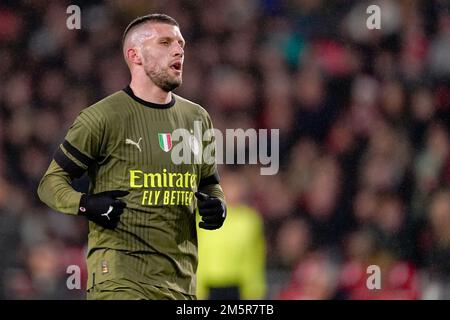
37 114 128 229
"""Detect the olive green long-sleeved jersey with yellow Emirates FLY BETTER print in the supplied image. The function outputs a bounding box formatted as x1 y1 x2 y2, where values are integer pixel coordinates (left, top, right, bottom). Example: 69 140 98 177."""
38 87 223 295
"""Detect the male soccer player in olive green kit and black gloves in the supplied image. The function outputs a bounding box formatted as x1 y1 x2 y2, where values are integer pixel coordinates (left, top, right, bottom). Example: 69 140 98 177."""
38 14 226 299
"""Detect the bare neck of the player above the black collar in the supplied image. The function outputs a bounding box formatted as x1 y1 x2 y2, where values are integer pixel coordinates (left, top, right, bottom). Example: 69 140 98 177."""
130 74 172 104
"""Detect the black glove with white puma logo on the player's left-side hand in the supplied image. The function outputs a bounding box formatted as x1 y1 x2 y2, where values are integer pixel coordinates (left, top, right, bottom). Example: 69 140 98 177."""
78 190 129 229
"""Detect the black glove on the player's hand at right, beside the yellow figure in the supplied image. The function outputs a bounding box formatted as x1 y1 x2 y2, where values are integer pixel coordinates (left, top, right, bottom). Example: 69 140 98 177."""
195 191 227 230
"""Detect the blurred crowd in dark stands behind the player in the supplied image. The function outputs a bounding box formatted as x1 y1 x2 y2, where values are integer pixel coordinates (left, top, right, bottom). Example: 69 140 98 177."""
0 0 450 299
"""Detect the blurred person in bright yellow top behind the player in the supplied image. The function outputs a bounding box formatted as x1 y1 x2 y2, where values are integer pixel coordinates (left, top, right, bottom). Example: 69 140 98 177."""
197 172 267 300
